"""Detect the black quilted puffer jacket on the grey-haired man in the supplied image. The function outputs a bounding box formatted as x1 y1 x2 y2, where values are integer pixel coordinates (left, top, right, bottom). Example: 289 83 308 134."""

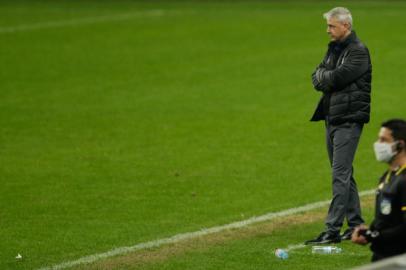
311 31 372 124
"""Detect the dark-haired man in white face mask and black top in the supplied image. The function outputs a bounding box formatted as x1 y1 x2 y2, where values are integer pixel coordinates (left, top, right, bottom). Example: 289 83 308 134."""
352 119 406 261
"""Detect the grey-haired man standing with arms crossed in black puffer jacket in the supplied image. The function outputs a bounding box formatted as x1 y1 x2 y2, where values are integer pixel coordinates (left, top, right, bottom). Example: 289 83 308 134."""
305 7 372 244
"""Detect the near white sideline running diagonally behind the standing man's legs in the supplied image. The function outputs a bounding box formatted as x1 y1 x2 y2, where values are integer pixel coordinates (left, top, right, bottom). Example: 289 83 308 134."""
38 189 375 270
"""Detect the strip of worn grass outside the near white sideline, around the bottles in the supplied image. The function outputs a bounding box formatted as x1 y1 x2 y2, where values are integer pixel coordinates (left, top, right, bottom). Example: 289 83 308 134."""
74 196 373 270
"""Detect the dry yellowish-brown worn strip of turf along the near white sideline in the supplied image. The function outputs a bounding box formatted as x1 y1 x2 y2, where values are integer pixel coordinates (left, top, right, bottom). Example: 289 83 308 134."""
76 196 374 270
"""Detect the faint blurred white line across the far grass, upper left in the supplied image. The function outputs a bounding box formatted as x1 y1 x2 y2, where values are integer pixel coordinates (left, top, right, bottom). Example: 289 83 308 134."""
0 10 165 33
